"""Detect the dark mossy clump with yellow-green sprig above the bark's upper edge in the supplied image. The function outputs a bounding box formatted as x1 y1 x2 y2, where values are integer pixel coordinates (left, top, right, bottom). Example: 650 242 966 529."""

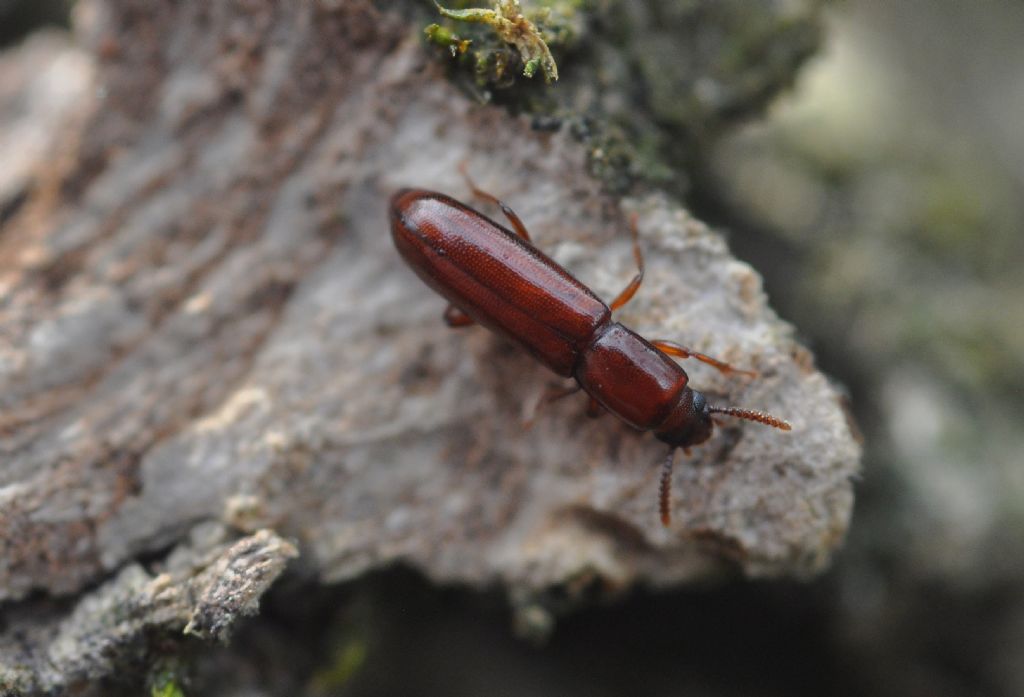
415 0 823 192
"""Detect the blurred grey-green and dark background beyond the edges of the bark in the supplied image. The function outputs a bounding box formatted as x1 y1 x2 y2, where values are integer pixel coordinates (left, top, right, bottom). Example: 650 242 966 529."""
0 0 1024 697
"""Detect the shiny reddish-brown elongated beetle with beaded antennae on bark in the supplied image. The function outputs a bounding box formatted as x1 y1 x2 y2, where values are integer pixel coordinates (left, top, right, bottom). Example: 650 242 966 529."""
389 170 791 526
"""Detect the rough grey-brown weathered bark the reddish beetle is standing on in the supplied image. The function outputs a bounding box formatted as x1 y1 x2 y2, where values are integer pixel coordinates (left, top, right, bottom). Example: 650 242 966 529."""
0 2 859 690
